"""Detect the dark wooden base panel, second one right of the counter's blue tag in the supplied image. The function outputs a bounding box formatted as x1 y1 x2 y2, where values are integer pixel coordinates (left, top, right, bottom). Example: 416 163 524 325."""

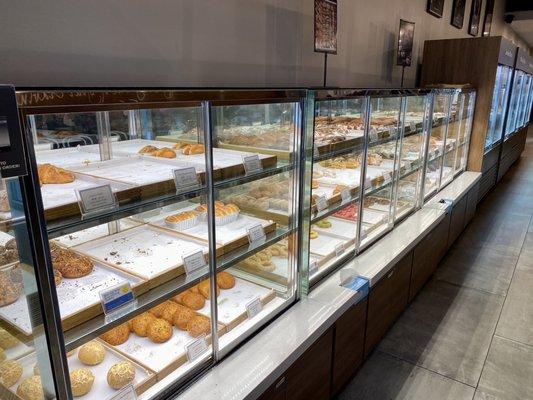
409 214 450 301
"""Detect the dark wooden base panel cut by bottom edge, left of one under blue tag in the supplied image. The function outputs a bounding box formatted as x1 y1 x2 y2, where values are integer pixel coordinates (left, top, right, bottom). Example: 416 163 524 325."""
285 329 333 400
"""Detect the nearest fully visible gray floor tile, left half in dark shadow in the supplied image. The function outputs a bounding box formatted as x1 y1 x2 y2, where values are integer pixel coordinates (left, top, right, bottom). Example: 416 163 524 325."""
379 280 504 386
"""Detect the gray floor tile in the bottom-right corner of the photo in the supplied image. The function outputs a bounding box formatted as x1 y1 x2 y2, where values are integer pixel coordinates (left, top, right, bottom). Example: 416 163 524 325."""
474 336 533 400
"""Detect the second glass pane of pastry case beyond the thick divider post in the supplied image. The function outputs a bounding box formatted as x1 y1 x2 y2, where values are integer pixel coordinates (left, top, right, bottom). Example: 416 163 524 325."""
360 93 403 248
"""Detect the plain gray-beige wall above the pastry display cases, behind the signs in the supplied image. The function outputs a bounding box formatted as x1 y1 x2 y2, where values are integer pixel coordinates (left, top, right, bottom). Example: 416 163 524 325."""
0 0 519 86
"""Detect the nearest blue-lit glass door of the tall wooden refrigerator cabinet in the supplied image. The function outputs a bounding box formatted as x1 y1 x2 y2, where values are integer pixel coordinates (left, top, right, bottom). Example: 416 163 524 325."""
485 65 513 152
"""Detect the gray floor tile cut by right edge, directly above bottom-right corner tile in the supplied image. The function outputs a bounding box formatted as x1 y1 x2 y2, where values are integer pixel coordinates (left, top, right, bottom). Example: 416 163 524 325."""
496 270 533 345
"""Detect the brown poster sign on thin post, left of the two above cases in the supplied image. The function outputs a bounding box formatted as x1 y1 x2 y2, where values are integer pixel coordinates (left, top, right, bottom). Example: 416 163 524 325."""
315 0 337 54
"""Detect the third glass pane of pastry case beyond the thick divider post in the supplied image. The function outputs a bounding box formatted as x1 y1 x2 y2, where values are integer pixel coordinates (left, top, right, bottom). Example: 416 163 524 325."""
394 91 430 221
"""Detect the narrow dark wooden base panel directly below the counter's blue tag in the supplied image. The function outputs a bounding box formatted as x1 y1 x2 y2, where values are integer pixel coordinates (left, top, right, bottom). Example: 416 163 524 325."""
331 299 367 396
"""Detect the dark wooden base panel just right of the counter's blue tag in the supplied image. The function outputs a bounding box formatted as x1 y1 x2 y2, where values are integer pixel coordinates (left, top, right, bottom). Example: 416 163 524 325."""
365 251 413 357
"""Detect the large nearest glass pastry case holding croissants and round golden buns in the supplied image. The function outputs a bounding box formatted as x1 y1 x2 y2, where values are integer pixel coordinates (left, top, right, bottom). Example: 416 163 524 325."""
0 90 305 400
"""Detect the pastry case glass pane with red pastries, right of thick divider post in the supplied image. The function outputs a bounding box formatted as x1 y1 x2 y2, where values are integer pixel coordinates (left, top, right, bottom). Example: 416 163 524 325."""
309 96 367 285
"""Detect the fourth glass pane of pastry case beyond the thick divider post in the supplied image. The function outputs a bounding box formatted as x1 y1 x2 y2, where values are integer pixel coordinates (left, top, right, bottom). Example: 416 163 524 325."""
424 90 451 198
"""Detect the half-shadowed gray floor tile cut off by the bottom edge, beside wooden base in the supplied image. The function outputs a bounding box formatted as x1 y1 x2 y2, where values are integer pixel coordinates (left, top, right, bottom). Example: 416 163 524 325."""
338 351 474 400
